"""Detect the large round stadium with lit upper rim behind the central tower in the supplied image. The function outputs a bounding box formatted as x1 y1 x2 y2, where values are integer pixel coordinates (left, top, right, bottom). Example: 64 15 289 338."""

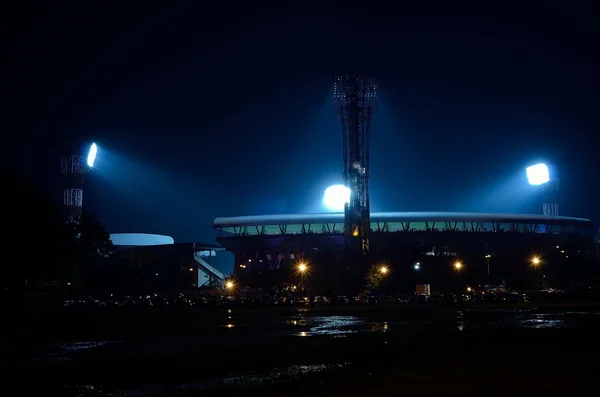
213 212 597 288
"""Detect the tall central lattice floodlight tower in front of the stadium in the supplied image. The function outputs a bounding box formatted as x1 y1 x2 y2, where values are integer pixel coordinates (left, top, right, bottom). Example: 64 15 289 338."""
333 75 377 252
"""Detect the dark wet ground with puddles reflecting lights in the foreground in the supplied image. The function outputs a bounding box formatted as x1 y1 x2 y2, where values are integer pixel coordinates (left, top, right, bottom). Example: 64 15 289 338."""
1 306 600 396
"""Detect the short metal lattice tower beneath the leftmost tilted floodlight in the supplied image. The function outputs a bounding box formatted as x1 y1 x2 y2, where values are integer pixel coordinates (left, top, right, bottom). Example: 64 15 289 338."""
60 154 87 223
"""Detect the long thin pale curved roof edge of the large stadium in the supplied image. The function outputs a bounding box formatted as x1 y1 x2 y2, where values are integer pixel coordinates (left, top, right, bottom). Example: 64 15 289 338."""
213 212 592 229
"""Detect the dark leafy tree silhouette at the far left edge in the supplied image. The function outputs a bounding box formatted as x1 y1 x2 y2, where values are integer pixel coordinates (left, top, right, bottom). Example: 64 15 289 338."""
0 169 111 292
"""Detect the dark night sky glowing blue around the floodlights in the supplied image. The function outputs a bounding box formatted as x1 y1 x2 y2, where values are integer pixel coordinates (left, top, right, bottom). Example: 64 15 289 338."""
2 1 600 242
